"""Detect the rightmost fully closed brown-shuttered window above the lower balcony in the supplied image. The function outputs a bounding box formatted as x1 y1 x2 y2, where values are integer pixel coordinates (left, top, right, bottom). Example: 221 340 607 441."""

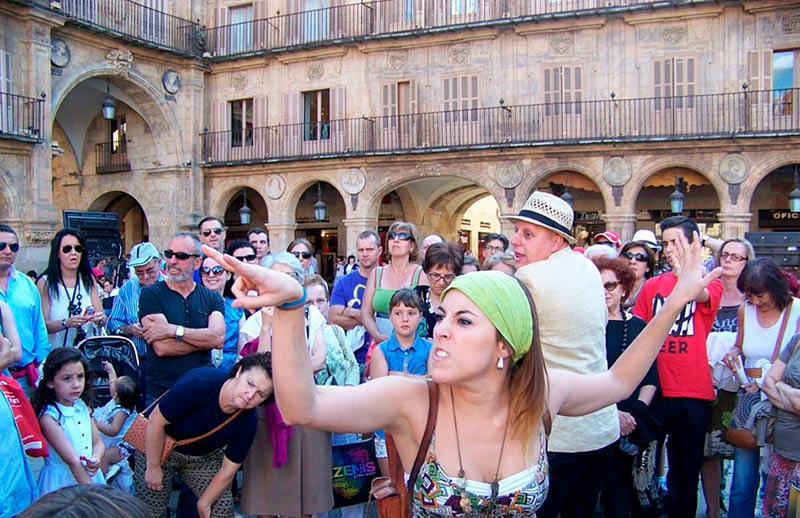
653 58 695 110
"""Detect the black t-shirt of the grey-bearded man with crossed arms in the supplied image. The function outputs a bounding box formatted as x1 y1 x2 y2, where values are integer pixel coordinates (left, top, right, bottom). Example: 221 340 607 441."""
139 281 225 398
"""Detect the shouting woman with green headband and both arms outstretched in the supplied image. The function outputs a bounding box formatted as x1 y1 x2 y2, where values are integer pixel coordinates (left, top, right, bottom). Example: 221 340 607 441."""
203 236 720 516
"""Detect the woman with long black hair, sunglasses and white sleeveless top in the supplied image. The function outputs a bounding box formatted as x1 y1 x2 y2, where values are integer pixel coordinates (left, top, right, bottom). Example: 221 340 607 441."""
37 228 106 347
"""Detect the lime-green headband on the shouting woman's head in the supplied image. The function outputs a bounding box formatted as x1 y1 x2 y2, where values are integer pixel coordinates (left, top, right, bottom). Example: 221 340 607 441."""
441 270 533 363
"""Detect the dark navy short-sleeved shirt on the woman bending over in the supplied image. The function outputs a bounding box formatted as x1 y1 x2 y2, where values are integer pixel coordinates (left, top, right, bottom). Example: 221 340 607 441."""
158 367 258 464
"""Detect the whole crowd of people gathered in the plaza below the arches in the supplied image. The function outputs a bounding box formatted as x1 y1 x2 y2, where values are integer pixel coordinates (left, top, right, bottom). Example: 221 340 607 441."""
0 192 800 518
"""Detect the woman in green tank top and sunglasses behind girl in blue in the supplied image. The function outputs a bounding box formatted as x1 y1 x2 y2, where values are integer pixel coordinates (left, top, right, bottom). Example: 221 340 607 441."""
361 221 428 343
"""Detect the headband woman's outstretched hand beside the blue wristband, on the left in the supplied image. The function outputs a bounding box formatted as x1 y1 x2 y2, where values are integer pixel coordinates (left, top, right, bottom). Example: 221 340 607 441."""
202 245 303 309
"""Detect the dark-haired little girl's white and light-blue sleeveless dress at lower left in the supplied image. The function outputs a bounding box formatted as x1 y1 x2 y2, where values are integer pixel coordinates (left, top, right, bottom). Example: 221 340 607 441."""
37 399 106 496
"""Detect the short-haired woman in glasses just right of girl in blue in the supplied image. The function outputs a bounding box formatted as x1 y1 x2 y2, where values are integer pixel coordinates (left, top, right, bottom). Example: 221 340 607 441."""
415 243 464 338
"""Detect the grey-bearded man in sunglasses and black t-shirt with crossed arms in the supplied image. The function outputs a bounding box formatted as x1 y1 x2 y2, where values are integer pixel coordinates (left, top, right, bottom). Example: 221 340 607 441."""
139 232 225 404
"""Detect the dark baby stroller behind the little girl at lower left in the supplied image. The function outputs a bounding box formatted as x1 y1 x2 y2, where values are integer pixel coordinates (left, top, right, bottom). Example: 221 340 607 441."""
78 336 139 406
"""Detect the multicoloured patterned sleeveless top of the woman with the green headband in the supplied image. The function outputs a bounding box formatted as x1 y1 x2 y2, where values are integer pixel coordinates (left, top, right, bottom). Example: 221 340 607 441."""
412 432 549 517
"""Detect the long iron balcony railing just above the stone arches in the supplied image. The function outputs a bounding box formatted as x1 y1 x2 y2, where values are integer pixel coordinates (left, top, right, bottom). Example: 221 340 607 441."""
202 89 800 165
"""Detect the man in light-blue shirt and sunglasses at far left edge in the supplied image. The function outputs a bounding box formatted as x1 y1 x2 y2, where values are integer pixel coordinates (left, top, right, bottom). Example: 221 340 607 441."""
0 224 50 397
